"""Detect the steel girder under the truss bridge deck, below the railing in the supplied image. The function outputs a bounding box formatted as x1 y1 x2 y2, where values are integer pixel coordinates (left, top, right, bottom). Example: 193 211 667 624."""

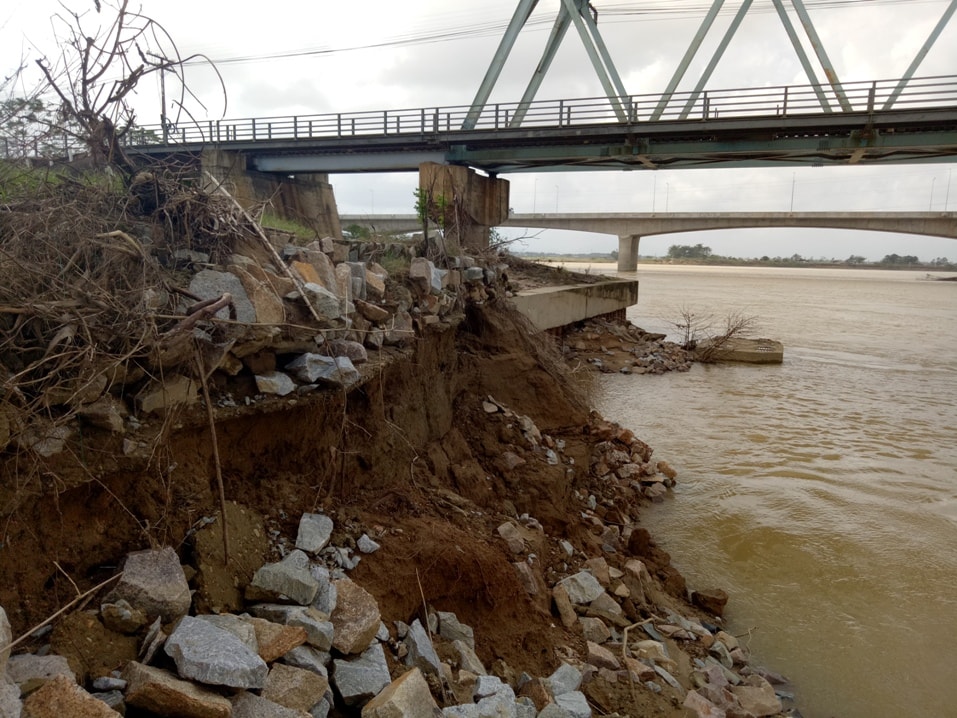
211 108 957 174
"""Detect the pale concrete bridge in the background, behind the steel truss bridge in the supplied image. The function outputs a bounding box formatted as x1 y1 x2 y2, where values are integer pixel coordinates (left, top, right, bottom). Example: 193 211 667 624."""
339 212 957 272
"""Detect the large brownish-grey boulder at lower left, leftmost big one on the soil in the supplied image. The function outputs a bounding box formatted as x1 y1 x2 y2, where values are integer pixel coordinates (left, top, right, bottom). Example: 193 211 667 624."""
107 546 192 623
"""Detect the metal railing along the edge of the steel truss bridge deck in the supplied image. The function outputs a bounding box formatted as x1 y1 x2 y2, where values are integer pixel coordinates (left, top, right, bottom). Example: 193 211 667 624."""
117 76 957 146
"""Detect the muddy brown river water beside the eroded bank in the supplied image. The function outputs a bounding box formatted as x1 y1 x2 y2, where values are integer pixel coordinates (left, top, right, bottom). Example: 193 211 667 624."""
599 265 957 718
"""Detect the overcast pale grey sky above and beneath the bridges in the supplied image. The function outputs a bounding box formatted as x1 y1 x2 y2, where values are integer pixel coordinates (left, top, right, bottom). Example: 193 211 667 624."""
0 0 957 260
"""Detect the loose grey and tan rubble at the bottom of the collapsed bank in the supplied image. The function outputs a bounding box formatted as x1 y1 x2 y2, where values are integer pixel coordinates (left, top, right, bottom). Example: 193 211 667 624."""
0 397 789 718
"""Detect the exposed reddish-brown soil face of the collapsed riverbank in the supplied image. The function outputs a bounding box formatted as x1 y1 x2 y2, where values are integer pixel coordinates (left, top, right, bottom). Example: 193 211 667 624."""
0 294 708 716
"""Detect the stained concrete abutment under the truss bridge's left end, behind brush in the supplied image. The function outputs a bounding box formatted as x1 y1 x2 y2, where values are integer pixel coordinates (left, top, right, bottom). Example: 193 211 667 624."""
202 150 342 238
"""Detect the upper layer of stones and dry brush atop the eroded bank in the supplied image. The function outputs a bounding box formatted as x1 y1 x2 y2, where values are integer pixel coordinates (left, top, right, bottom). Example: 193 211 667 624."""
0 201 497 458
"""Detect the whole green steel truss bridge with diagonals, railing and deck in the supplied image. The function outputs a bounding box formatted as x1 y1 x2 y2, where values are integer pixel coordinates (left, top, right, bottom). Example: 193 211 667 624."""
134 0 957 175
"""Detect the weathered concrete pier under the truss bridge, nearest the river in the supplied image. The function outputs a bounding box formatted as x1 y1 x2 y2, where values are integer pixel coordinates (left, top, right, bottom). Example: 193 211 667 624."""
419 162 508 250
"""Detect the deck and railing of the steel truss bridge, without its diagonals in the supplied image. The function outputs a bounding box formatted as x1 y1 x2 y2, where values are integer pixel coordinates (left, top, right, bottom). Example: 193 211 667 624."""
133 76 957 175
